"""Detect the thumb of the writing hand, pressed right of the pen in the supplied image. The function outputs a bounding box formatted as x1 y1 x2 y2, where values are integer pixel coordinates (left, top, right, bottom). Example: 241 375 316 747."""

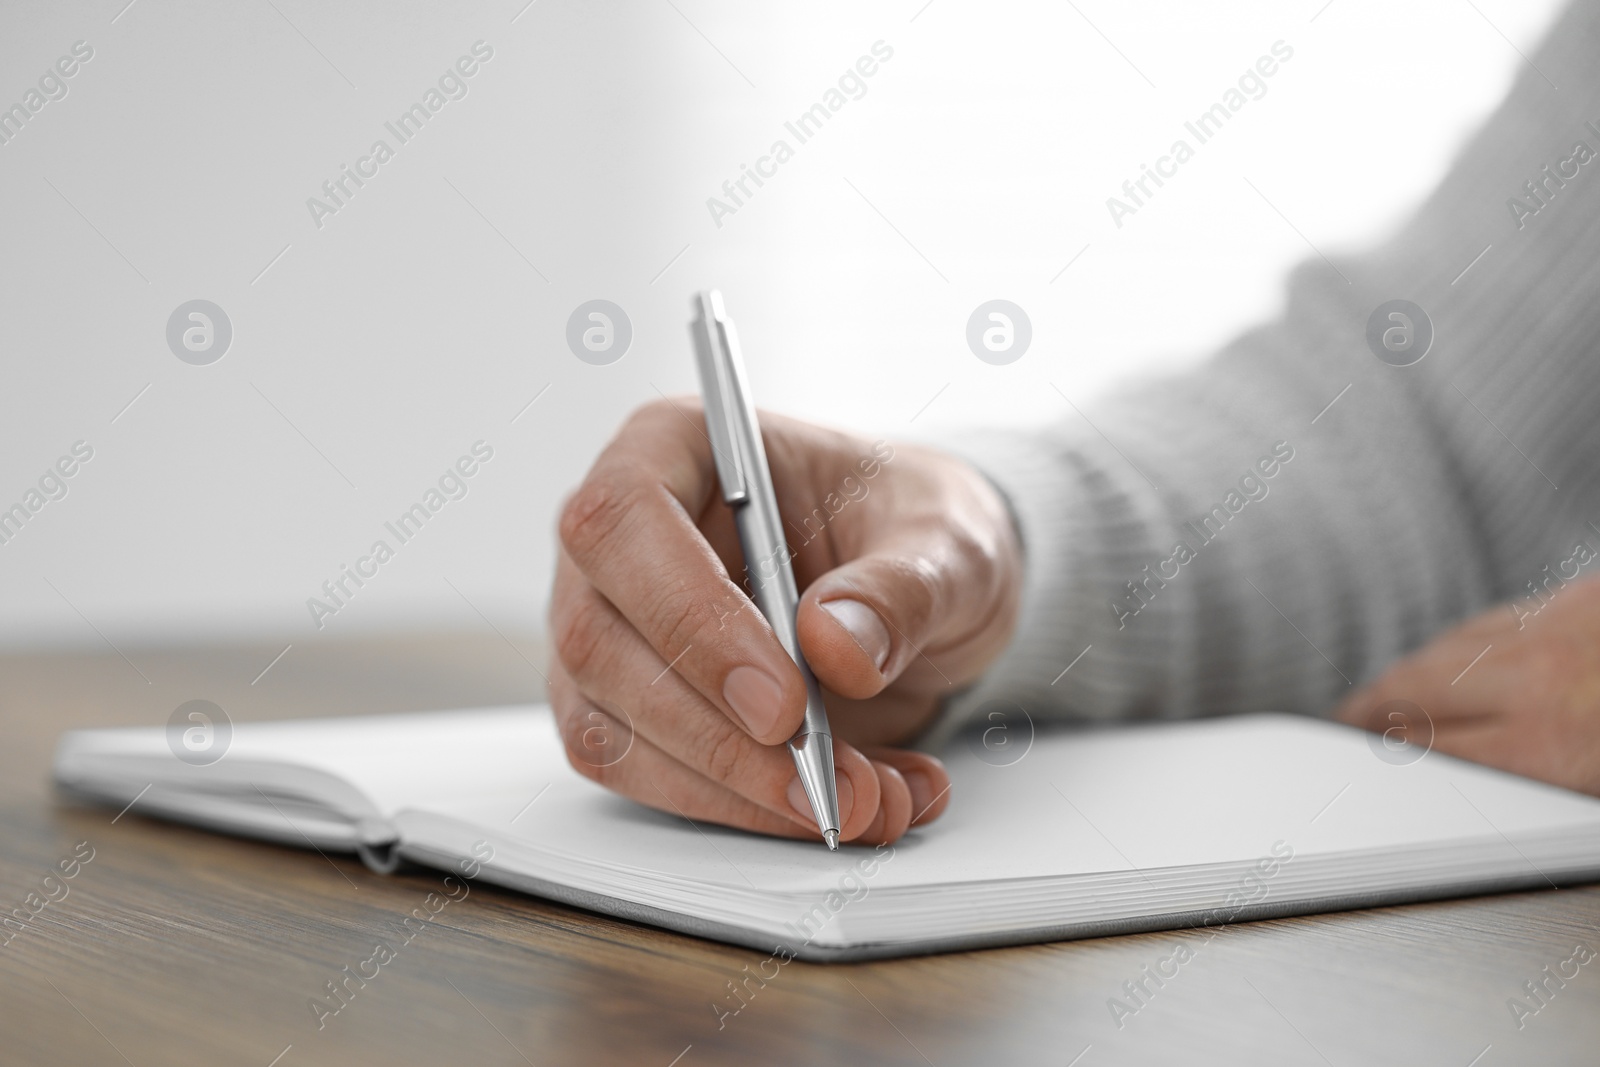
795 544 960 701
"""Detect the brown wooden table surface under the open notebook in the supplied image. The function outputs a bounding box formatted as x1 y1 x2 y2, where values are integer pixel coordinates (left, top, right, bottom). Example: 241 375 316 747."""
0 633 1600 1067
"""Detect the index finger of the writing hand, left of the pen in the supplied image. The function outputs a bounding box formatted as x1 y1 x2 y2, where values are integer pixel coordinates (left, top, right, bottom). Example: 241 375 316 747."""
560 402 806 744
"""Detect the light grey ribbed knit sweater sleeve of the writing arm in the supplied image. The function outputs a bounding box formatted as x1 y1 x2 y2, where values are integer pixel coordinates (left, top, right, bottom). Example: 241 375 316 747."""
925 2 1600 744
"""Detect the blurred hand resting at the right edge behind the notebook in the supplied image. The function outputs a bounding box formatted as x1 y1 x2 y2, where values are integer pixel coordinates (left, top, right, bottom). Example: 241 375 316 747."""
1336 579 1600 795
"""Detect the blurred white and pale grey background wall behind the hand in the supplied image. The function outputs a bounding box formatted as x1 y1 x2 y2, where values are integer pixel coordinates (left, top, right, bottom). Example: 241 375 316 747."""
0 0 1555 646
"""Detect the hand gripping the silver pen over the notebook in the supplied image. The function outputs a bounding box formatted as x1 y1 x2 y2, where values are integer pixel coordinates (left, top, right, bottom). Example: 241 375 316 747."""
550 400 1021 843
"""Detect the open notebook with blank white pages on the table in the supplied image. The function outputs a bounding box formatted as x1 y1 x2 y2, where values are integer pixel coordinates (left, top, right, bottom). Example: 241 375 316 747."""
54 707 1600 960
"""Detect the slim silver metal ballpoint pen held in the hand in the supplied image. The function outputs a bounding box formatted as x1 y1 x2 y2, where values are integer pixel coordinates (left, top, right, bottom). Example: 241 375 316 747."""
690 290 838 849
